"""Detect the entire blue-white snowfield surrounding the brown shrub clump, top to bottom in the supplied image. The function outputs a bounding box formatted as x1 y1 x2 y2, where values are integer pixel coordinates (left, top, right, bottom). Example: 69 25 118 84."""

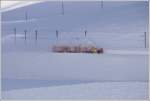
2 1 149 99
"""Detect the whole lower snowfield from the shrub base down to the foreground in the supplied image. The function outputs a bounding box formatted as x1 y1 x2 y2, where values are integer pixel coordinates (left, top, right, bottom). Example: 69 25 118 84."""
2 52 148 99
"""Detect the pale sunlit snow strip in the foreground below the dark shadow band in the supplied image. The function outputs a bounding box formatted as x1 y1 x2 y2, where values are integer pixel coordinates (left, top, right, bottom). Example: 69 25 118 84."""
2 82 148 100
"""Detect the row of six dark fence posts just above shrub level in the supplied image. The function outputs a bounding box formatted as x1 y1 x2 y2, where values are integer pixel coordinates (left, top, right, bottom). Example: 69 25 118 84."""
14 28 147 48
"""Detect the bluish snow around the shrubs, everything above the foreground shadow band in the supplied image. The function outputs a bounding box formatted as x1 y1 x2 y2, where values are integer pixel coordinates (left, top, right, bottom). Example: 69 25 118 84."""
2 1 148 85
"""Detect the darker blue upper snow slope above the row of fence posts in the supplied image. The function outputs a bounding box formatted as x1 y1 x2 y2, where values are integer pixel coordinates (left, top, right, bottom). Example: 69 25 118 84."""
2 1 148 32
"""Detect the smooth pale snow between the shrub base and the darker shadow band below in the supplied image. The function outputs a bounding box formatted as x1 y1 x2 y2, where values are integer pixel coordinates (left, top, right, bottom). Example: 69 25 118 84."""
2 52 148 81
